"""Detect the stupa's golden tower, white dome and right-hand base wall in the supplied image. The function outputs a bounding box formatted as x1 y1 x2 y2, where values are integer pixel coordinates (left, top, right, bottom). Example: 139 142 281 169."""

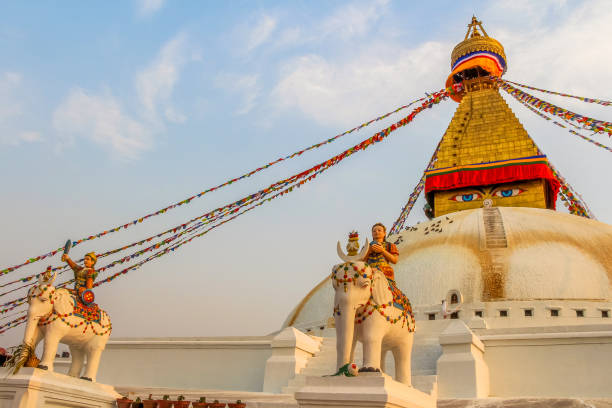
284 18 612 398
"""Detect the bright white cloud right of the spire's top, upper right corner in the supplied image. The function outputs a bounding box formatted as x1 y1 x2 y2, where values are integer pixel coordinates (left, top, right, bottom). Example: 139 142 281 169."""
489 1 612 97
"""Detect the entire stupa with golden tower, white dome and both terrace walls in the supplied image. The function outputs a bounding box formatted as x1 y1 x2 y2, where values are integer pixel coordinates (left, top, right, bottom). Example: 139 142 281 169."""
0 18 612 408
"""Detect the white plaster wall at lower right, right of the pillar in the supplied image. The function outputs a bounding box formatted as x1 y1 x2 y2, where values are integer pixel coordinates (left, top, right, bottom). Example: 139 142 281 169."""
480 325 612 398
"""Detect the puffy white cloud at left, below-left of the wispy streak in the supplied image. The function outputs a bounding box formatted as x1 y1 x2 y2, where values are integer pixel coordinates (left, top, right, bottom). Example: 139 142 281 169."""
53 88 152 159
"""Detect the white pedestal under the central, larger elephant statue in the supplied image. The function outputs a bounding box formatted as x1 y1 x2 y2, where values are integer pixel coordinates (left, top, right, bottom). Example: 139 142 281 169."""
295 373 436 408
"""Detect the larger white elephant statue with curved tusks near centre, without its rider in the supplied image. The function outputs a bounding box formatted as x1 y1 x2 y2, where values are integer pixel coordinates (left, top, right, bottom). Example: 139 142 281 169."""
331 243 415 386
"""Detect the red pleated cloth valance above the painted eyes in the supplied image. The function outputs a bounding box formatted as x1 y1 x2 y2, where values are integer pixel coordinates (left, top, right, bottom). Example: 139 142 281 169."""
425 163 560 210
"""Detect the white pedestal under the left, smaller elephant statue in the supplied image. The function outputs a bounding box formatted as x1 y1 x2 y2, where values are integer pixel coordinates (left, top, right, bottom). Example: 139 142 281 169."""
0 368 121 408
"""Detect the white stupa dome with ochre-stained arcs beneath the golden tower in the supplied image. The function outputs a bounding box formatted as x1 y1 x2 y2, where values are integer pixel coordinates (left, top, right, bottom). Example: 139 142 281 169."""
284 207 612 326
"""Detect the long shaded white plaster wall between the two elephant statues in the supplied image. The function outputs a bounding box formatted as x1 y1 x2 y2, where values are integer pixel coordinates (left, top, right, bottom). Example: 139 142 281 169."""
67 336 272 392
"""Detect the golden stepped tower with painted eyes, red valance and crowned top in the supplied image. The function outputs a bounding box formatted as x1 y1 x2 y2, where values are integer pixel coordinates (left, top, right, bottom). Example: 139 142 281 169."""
425 17 559 217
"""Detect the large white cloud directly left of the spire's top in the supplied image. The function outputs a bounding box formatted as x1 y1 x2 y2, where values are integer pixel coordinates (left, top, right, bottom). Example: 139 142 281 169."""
271 42 451 125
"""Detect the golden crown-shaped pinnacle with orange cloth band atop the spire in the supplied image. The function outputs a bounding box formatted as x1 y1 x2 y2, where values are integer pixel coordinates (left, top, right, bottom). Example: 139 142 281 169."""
446 17 507 102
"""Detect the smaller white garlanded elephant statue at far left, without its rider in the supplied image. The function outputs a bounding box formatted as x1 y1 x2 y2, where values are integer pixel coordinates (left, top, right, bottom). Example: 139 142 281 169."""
23 273 112 381
